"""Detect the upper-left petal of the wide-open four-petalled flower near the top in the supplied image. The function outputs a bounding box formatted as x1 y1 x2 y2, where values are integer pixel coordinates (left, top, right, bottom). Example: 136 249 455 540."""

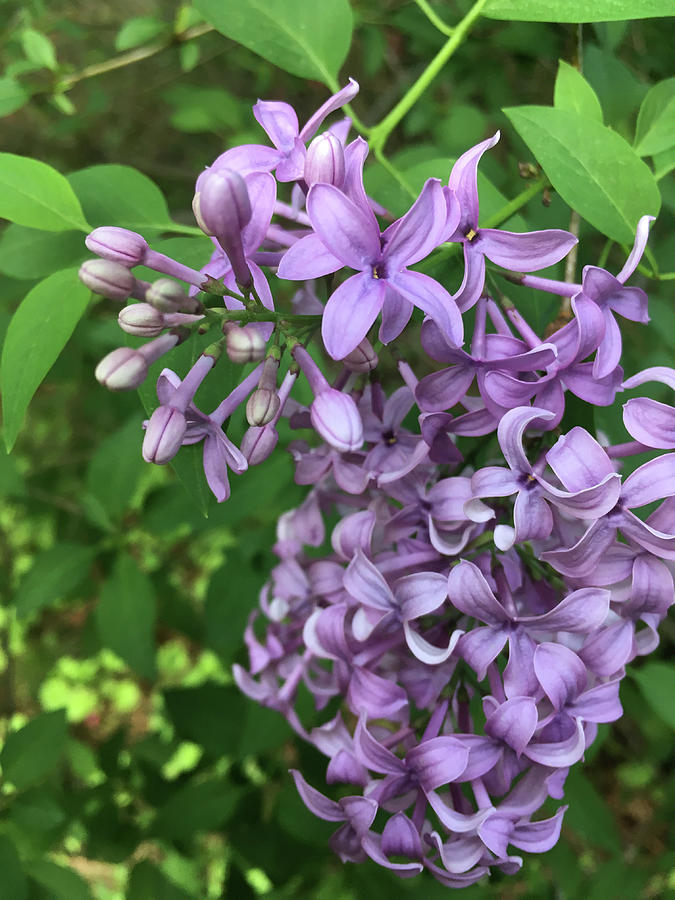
307 183 381 274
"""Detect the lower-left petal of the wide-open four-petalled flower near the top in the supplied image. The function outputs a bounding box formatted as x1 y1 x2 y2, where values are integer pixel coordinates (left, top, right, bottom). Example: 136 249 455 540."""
321 272 385 359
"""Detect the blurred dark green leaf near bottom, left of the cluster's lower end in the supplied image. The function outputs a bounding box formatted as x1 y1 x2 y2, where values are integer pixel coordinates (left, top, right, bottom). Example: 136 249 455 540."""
153 778 242 840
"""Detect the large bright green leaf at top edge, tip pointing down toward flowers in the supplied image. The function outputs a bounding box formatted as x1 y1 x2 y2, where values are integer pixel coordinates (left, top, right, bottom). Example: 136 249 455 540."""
194 0 352 90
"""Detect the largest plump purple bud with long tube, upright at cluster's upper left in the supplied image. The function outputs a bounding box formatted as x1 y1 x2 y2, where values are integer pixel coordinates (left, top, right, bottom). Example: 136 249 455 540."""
193 169 251 285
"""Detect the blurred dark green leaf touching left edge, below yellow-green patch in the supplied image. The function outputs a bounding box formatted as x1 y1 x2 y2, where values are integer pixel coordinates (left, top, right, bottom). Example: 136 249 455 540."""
0 709 68 790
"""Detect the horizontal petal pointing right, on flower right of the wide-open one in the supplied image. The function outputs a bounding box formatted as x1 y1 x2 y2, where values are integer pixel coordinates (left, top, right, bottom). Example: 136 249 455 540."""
480 228 578 272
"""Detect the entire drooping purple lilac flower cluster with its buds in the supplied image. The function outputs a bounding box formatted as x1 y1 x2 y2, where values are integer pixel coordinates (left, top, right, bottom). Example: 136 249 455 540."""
82 82 675 887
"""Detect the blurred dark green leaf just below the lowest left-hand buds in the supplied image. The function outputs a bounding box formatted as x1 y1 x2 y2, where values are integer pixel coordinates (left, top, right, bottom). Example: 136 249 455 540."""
86 415 146 527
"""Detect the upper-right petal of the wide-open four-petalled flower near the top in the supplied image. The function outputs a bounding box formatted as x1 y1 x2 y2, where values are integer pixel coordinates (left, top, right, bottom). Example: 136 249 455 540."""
383 178 448 270
